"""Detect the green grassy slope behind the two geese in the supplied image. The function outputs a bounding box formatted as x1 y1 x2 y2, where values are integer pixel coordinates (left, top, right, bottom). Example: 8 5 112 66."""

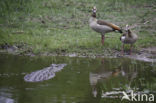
0 0 156 54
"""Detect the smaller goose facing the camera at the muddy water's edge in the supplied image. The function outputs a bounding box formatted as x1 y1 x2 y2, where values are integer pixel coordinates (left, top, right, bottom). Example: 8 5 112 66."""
120 25 138 55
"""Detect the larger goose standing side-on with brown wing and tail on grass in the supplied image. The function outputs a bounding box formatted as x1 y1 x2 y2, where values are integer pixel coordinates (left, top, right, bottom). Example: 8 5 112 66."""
89 6 122 44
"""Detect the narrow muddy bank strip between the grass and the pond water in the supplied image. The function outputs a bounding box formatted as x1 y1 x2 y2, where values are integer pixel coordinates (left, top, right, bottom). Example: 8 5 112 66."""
0 45 156 62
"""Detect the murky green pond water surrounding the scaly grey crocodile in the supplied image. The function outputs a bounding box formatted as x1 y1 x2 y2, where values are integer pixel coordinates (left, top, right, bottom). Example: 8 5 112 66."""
0 54 156 103
